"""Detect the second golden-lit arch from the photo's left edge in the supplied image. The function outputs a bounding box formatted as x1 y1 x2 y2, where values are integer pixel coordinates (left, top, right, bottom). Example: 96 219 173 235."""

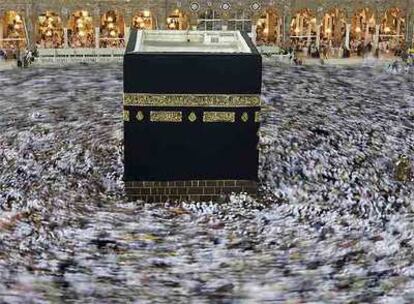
36 11 64 48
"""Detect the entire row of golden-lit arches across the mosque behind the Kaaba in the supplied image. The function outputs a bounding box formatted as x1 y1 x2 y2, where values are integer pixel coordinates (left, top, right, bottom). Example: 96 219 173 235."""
0 8 407 54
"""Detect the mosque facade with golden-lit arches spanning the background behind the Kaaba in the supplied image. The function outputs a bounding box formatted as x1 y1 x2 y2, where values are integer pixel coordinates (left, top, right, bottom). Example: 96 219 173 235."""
0 0 414 48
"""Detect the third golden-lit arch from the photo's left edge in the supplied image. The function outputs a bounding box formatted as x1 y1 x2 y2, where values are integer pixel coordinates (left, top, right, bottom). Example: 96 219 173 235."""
68 10 95 48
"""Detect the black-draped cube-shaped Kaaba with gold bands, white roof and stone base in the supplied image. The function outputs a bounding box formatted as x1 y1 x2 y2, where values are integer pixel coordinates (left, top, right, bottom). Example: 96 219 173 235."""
123 30 262 202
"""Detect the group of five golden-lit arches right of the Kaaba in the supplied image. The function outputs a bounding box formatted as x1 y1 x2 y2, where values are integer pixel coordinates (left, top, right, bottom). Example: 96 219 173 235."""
256 8 407 51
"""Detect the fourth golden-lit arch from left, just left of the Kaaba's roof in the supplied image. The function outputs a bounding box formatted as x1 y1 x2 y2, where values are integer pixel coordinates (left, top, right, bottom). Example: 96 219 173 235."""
99 10 125 48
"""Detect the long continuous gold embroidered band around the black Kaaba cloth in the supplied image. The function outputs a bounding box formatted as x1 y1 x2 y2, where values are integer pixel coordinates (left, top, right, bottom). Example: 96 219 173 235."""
124 93 261 107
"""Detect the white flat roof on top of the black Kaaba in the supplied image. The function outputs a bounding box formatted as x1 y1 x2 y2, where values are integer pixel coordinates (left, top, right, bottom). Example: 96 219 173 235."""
134 30 252 53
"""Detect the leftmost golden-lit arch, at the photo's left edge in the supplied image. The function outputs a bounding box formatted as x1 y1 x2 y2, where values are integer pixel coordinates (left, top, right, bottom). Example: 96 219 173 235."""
2 11 27 50
